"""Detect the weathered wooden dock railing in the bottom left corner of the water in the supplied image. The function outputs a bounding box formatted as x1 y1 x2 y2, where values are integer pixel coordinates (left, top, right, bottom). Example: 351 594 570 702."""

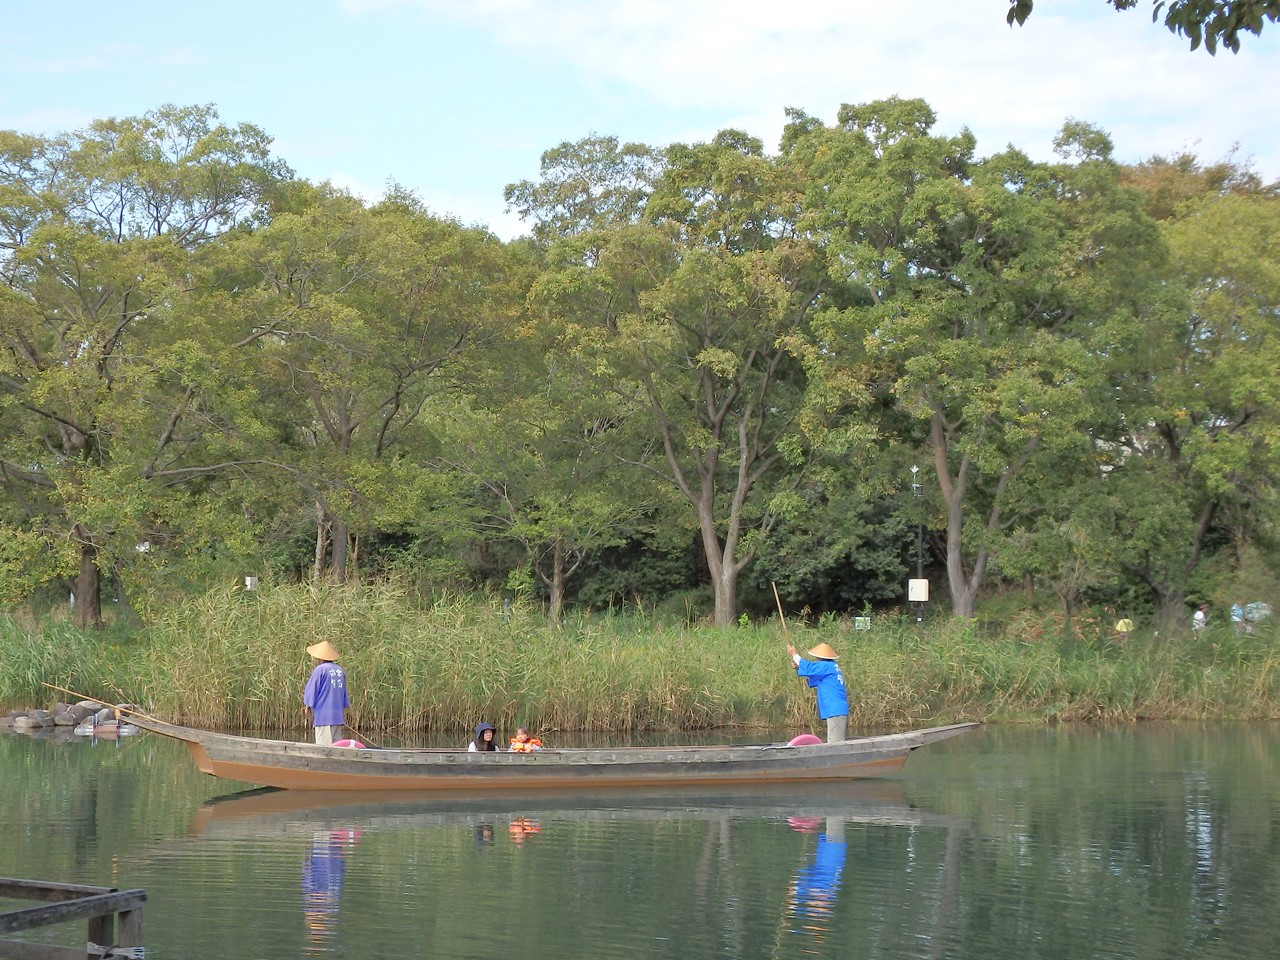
0 877 147 960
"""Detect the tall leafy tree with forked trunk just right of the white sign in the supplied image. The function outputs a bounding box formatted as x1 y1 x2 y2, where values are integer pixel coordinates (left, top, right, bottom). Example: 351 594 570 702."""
785 99 1153 616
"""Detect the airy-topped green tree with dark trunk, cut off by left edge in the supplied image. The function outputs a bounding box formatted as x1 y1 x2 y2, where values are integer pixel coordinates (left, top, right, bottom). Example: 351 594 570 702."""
0 106 287 626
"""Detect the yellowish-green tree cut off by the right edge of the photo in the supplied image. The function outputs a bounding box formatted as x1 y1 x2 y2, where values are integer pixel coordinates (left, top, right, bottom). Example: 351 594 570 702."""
1106 193 1280 622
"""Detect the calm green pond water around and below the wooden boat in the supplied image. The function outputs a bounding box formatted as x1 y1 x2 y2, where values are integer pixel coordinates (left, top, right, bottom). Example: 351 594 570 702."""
0 726 1280 960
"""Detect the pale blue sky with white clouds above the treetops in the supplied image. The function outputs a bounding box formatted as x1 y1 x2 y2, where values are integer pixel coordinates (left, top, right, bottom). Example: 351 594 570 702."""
0 0 1280 239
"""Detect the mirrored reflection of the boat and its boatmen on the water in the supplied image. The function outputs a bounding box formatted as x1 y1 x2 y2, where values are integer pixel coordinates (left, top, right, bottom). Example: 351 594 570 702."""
189 781 963 955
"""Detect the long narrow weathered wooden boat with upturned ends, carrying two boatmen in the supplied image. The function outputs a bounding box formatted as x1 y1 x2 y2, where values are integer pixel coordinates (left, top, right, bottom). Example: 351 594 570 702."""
128 710 980 792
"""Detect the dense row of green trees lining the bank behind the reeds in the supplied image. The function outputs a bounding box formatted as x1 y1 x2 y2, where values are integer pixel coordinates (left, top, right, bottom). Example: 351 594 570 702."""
0 99 1280 626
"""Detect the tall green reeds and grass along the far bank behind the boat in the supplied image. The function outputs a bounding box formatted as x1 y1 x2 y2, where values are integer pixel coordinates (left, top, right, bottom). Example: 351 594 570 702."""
0 585 1280 735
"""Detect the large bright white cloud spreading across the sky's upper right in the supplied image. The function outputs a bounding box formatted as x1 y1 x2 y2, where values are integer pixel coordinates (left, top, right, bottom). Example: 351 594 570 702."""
344 0 1280 177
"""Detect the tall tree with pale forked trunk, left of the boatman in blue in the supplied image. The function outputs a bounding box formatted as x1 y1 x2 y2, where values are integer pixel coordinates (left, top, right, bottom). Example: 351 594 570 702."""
522 131 824 625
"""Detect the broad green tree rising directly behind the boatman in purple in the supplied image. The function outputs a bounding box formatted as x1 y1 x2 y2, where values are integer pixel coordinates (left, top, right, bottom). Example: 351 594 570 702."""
228 183 520 581
